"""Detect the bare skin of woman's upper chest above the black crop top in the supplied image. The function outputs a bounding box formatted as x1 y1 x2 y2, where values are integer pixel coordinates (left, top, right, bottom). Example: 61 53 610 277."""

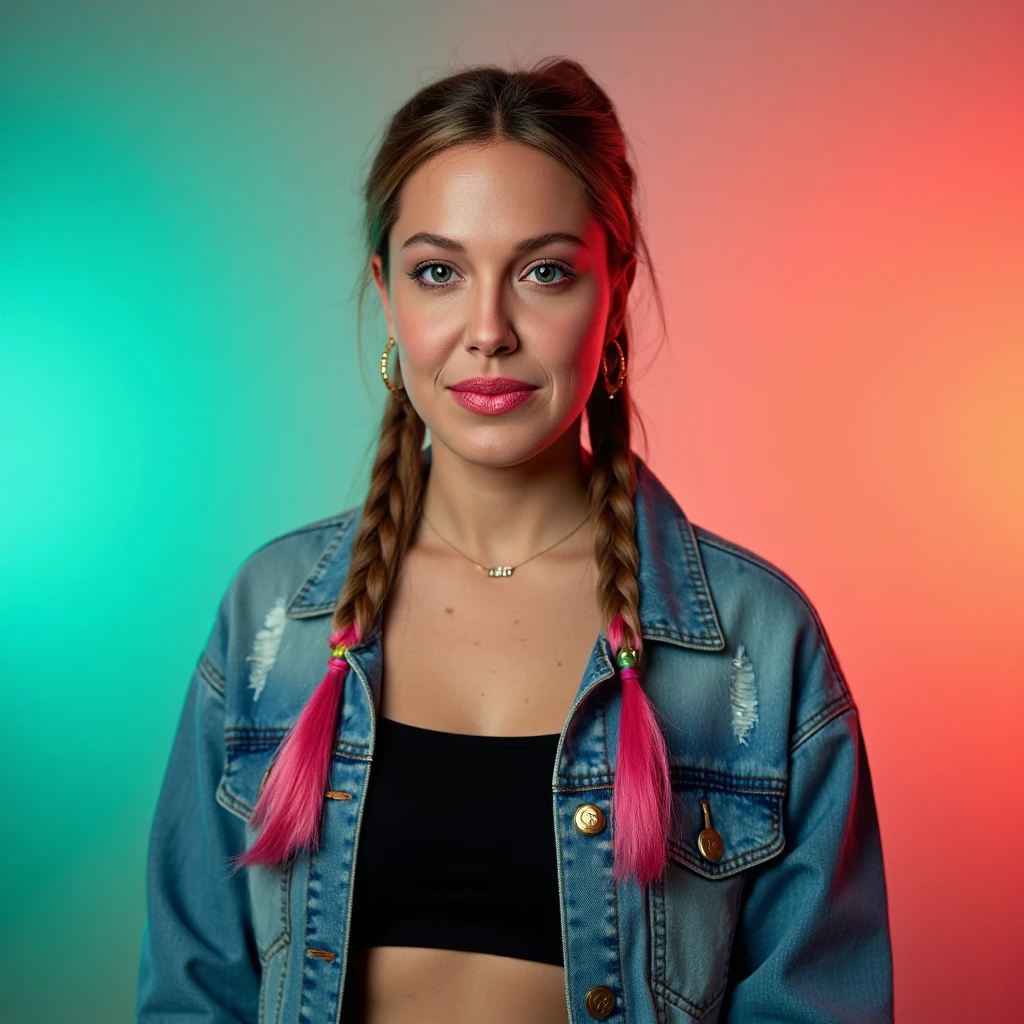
381 550 603 735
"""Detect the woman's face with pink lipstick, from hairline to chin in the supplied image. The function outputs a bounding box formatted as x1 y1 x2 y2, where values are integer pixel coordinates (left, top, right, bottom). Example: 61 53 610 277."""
372 141 628 466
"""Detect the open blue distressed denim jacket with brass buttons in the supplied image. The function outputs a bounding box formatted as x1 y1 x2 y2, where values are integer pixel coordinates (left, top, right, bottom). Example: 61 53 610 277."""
137 446 892 1024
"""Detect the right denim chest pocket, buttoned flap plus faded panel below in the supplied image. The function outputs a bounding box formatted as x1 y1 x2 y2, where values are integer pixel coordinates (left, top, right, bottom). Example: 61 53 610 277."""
649 768 784 1024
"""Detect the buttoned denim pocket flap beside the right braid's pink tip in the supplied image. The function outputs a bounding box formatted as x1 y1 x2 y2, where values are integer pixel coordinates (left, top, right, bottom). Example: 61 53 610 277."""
668 767 785 879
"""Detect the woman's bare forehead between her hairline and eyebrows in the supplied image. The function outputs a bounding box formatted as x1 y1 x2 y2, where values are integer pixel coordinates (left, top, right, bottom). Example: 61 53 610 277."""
391 141 594 247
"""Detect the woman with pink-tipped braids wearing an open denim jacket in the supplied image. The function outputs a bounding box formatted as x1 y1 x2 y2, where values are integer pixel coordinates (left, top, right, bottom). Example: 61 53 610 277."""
138 59 892 1024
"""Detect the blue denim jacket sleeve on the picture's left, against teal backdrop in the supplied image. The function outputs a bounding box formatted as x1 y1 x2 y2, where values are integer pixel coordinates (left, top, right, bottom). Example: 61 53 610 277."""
136 604 260 1024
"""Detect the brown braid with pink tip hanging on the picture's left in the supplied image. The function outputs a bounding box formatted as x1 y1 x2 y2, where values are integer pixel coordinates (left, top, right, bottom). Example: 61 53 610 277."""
236 392 426 866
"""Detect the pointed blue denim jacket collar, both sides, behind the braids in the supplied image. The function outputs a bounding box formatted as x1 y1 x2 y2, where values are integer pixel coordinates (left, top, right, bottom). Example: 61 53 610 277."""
285 445 725 650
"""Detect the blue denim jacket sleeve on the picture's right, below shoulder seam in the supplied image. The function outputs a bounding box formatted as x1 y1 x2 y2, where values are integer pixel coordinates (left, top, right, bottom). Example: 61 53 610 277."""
723 699 893 1024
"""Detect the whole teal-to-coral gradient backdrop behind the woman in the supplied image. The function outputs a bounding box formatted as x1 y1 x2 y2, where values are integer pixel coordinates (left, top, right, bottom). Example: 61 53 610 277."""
0 0 1024 1024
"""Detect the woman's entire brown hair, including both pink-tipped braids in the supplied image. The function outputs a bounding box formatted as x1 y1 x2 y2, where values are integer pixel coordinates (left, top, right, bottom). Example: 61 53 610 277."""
240 57 672 885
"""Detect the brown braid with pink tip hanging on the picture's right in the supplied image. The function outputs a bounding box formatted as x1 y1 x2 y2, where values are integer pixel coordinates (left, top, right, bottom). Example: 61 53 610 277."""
587 329 672 885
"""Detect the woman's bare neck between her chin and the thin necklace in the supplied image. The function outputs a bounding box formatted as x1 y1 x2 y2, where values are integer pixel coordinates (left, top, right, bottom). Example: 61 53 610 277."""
415 427 592 564
